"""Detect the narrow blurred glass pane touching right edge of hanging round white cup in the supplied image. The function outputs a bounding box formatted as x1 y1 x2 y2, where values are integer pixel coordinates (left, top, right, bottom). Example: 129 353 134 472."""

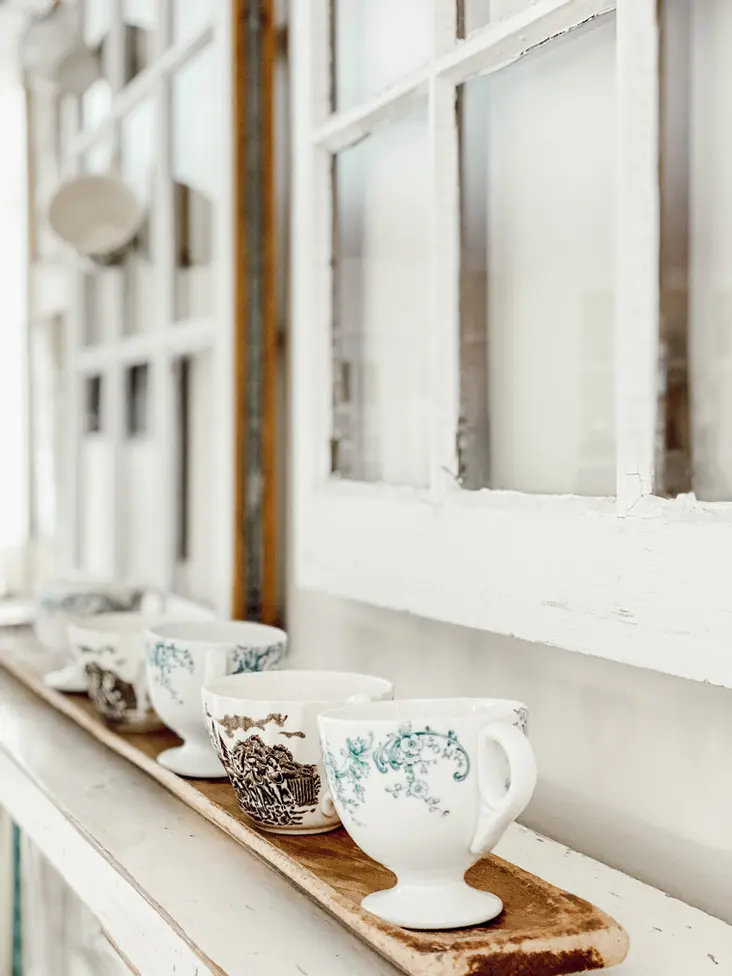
120 101 158 332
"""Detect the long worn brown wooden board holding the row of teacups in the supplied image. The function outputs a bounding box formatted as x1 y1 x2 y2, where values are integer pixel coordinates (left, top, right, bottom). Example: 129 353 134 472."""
0 649 628 976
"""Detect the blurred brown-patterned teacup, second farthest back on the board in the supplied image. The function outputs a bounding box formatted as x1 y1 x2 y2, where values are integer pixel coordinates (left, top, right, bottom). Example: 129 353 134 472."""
69 613 162 732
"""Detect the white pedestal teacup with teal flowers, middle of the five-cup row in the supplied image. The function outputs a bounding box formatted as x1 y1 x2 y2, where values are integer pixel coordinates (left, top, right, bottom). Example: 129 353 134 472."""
146 620 287 779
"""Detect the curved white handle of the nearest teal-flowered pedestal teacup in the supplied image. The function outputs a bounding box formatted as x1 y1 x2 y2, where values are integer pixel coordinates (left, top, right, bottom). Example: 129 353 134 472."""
470 722 536 854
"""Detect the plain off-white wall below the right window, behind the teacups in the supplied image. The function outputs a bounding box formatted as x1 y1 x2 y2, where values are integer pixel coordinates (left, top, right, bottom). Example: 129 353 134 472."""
288 586 732 924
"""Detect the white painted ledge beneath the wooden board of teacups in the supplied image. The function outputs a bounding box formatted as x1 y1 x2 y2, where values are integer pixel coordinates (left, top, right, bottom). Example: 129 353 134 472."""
0 672 732 976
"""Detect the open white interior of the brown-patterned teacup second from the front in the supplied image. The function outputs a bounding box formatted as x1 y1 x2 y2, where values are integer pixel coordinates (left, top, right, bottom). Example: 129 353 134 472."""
204 671 391 704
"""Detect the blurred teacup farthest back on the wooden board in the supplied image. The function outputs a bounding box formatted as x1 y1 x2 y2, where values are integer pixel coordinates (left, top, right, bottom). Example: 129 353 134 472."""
34 579 145 691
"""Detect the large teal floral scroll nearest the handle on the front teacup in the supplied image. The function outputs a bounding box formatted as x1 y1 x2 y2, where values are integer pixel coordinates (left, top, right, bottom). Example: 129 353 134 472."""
374 723 470 817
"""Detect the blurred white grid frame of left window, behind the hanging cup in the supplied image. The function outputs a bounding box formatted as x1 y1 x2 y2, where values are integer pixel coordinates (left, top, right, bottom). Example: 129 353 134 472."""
62 0 234 615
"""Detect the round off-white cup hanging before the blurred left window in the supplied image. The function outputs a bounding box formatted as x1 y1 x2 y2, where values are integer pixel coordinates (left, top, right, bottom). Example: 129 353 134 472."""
48 174 145 264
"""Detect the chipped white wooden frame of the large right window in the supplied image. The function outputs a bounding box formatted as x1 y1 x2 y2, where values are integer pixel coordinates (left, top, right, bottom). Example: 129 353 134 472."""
291 0 732 687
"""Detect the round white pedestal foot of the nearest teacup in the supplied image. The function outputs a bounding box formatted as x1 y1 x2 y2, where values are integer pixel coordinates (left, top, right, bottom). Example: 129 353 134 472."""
361 881 503 930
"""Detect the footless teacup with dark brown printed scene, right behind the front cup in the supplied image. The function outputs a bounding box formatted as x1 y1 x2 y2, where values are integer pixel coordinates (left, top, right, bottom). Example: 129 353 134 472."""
203 671 394 834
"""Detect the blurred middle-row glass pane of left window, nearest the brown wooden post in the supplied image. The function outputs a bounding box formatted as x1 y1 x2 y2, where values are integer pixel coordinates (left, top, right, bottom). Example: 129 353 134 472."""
172 49 217 320
